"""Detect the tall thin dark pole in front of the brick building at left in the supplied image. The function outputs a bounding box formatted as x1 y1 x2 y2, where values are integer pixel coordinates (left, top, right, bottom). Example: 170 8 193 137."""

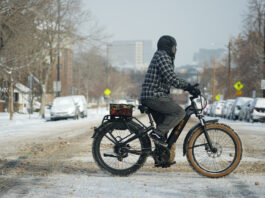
56 0 61 97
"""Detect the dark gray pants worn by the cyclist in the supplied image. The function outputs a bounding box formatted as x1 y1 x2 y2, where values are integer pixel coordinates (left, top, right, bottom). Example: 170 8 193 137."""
141 96 186 135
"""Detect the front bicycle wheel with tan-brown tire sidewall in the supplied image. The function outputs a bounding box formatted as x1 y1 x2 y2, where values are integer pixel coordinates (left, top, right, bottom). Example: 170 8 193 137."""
187 123 242 178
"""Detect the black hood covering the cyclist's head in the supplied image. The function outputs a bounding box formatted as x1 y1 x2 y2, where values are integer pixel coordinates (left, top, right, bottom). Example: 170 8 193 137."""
157 35 177 59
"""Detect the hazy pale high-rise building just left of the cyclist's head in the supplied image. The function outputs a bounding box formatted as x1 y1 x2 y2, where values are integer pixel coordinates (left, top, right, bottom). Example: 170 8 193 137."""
107 40 153 70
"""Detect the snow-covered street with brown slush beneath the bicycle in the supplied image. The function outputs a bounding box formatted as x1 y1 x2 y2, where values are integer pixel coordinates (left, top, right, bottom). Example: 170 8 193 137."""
0 109 265 198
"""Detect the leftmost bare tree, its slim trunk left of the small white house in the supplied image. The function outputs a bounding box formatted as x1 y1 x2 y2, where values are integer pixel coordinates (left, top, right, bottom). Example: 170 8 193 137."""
0 0 41 120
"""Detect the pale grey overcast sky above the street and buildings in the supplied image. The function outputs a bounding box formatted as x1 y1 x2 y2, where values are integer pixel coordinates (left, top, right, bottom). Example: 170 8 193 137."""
83 0 248 66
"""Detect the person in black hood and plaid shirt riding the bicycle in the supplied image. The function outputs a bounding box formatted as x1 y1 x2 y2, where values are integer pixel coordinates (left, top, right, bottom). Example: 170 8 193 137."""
141 35 200 147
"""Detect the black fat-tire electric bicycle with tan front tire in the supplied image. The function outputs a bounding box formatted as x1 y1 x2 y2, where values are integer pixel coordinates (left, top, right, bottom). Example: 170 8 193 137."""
92 95 243 178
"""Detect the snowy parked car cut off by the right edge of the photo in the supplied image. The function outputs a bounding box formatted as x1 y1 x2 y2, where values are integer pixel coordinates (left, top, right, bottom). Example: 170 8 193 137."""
246 98 265 122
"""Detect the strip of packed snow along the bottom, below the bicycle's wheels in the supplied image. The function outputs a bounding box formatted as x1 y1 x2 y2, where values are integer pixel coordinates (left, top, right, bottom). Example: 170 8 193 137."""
3 171 265 198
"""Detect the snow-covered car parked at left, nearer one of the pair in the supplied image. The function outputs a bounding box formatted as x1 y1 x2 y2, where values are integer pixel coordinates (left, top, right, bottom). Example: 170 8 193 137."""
50 97 79 120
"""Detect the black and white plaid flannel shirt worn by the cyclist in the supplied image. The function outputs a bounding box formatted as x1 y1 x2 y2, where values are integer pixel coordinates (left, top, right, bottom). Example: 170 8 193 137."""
141 50 188 100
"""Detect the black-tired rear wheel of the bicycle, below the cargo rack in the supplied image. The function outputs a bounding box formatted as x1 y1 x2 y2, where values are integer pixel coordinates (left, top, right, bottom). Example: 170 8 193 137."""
92 122 150 176
